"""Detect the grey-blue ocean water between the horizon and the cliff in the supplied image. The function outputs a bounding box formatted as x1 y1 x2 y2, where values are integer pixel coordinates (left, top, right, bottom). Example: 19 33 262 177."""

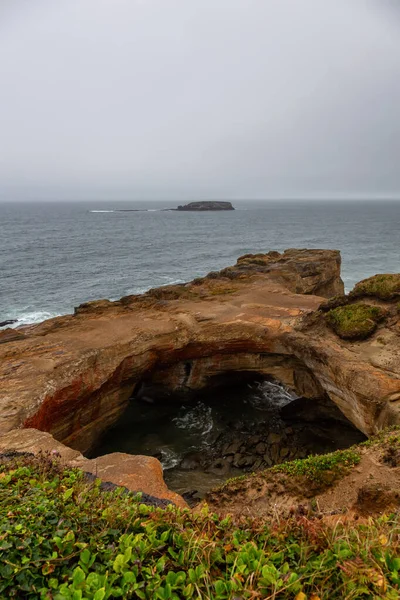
0 200 400 326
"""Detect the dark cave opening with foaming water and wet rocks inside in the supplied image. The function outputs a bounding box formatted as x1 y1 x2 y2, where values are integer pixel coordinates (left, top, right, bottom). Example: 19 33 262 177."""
90 363 366 504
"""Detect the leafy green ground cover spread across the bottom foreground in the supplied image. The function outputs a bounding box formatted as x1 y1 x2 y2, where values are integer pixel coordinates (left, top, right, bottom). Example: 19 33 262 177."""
0 454 400 600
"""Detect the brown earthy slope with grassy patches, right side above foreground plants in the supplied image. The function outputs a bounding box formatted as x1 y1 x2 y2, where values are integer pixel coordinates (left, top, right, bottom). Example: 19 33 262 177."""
205 431 400 519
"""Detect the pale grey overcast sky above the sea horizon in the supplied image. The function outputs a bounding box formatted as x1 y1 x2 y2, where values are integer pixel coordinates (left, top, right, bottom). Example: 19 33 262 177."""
0 0 400 199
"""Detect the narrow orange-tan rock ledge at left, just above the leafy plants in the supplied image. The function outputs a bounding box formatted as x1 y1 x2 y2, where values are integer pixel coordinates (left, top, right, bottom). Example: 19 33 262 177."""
0 429 187 508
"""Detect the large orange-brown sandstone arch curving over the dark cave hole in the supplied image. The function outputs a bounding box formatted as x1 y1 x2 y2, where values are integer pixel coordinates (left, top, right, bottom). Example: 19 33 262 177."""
0 250 400 460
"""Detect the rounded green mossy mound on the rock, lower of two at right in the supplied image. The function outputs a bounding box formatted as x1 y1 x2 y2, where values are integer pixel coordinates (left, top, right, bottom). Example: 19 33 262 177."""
325 304 384 340
